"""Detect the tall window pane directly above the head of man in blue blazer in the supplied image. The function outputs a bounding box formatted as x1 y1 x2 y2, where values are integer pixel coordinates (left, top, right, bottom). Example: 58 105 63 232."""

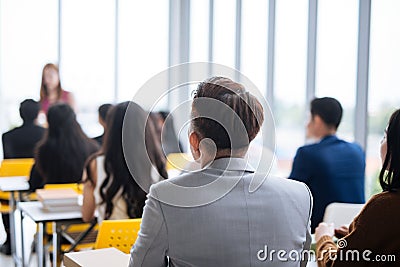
315 0 358 141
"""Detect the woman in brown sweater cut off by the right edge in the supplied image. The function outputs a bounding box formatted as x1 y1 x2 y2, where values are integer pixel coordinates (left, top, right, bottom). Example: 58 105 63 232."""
315 109 400 267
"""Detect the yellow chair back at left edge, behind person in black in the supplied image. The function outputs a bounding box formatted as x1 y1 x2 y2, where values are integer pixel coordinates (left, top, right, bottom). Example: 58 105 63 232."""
0 159 34 177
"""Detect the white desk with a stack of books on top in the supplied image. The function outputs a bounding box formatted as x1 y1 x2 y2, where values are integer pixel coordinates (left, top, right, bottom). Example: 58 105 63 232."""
18 201 82 266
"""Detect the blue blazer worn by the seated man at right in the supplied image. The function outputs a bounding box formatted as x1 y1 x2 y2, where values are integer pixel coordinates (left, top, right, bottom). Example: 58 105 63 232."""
289 135 365 232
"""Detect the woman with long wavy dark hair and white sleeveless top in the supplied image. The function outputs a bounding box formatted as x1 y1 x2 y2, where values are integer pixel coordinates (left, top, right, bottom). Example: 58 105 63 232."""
82 102 167 221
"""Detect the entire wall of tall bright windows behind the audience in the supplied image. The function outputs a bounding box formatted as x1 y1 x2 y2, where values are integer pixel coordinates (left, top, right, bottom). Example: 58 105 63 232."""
0 0 400 182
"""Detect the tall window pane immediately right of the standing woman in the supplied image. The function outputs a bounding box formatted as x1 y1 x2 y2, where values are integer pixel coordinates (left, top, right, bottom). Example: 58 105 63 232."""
60 0 115 136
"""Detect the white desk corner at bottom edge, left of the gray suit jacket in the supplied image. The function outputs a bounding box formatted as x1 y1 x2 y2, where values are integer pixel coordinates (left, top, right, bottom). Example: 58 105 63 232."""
64 248 130 267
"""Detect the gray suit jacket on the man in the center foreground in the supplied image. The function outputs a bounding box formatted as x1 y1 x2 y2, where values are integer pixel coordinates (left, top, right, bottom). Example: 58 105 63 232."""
130 158 312 266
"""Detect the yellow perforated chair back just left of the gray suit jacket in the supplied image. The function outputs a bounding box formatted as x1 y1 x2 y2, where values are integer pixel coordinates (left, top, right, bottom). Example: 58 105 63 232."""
94 219 142 253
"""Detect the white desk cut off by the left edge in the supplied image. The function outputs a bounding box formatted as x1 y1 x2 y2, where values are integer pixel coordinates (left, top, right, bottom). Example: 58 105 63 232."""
0 176 29 266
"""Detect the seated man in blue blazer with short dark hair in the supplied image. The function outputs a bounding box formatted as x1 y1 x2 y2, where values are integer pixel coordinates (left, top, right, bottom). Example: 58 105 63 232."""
289 97 365 232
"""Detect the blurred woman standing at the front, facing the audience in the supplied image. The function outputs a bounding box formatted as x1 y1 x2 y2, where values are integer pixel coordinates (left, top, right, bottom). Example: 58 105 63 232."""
40 63 75 113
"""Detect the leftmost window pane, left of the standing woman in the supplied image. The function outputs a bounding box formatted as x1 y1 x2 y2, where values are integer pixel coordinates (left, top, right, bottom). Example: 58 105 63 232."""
0 0 58 131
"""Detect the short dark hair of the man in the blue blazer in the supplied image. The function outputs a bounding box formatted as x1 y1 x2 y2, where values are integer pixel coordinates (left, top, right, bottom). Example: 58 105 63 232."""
311 97 343 129
